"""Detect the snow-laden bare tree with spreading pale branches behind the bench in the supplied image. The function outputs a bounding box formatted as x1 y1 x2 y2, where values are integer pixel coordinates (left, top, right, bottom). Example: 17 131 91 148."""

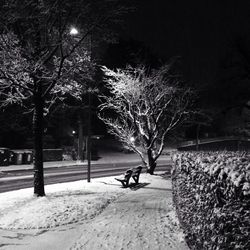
99 63 192 174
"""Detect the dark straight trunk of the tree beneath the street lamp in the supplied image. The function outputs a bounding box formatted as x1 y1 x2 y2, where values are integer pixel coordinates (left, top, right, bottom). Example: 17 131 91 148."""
33 93 45 196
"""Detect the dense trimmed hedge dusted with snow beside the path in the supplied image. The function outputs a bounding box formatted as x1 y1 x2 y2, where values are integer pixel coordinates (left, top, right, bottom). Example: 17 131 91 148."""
172 152 250 250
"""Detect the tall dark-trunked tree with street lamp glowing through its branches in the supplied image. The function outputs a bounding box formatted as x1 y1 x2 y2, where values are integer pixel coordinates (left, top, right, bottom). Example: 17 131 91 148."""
0 0 131 196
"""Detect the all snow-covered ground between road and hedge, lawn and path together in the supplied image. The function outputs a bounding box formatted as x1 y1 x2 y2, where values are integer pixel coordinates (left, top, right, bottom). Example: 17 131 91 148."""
0 174 188 250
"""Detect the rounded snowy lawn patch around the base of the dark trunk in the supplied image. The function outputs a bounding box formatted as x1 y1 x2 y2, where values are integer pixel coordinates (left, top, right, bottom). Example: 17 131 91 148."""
0 177 127 229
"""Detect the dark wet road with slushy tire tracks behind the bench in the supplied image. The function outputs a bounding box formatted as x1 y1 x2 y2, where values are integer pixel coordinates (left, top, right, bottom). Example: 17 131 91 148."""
0 161 171 193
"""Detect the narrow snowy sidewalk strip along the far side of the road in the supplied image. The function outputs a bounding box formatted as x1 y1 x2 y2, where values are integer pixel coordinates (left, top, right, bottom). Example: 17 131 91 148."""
0 152 170 172
